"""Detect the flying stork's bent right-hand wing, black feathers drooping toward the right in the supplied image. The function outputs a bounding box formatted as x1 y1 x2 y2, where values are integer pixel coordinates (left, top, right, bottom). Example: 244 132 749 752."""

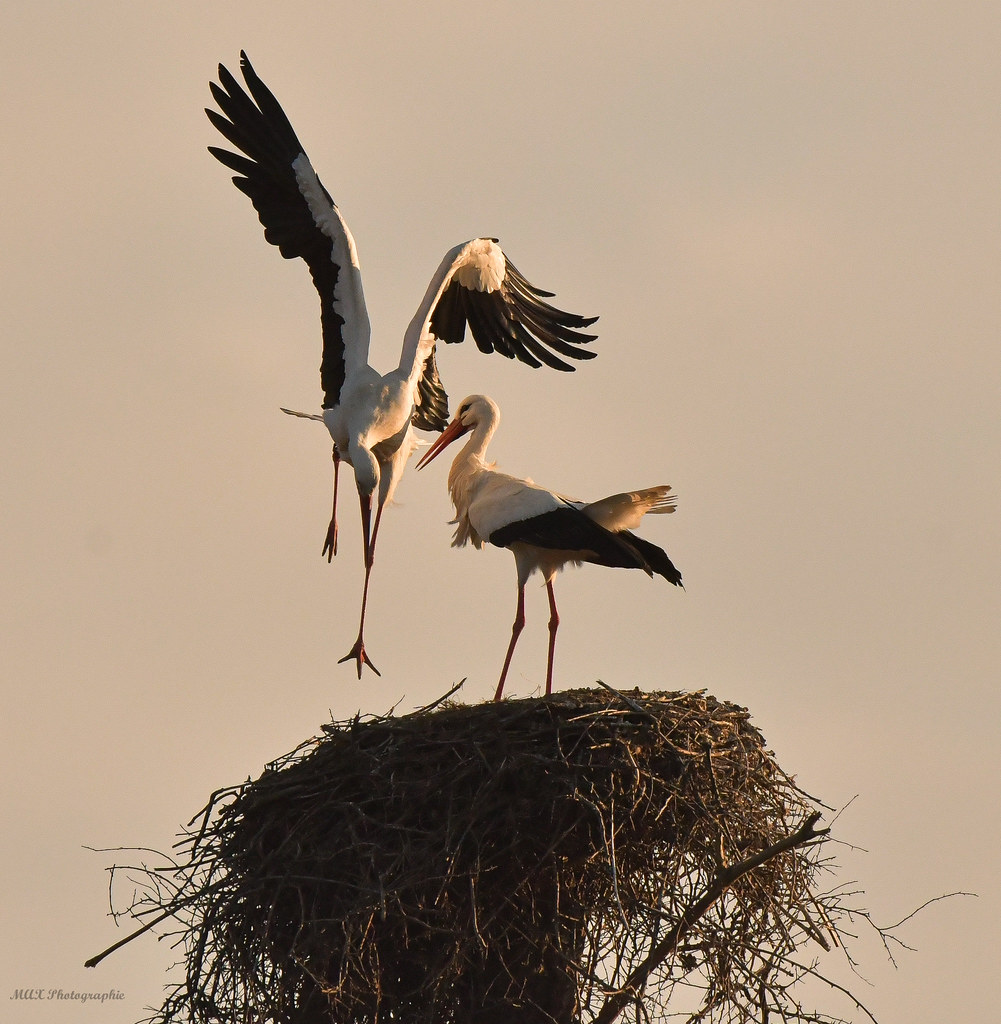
400 239 598 430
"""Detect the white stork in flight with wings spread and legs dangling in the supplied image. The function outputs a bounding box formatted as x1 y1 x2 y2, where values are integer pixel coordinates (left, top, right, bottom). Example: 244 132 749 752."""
206 58 598 679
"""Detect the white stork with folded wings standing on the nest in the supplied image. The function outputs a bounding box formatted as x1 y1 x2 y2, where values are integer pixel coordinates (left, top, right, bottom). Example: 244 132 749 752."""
418 394 682 700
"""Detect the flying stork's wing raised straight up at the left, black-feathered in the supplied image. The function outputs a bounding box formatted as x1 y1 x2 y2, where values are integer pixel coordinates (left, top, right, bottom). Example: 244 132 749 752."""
206 51 369 409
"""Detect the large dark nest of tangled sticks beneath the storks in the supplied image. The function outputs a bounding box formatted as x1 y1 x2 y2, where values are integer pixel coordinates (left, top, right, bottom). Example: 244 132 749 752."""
117 690 851 1024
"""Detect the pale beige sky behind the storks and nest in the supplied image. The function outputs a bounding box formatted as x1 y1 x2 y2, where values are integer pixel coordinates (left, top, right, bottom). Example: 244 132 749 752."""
0 0 1001 1024
